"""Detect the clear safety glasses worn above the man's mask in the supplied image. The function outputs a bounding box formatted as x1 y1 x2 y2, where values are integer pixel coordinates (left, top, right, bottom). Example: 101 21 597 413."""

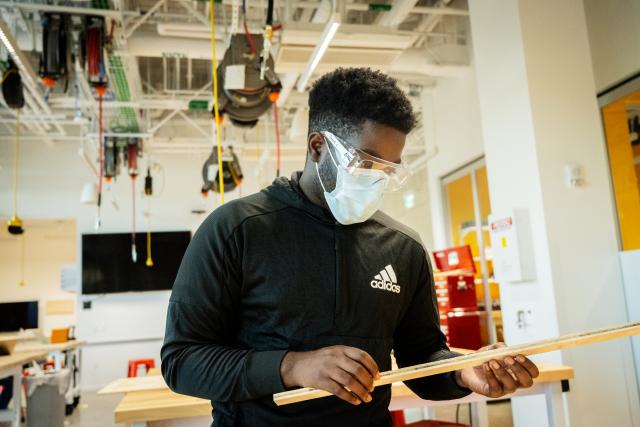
321 131 411 191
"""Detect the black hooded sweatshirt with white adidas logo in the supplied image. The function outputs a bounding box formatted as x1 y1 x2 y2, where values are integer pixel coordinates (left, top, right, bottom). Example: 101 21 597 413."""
161 172 470 427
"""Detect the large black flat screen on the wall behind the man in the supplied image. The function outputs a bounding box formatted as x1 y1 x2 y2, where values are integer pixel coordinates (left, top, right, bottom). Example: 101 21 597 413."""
82 231 191 294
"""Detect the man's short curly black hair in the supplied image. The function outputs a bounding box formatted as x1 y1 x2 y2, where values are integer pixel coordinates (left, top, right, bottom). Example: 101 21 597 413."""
309 68 416 138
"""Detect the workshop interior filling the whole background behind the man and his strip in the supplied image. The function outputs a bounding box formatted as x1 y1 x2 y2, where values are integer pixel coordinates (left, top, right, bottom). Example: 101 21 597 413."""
0 0 640 427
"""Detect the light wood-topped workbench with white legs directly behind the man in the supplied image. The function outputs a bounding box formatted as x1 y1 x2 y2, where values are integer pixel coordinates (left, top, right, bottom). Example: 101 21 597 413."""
105 364 574 427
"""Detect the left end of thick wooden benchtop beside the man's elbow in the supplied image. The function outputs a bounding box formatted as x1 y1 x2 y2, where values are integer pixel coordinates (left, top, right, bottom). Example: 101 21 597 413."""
114 388 212 424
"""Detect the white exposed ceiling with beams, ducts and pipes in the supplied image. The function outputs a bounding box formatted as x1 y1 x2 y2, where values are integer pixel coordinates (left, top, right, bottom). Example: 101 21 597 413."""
0 0 469 171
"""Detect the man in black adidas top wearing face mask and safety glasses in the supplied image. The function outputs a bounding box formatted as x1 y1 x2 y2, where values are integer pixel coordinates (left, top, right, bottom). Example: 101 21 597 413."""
162 68 538 427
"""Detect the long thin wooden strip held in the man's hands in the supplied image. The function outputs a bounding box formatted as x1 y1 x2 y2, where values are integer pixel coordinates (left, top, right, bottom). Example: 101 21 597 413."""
273 322 640 405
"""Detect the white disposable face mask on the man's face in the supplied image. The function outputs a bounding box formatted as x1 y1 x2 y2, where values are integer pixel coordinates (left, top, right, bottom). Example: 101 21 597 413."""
316 142 389 225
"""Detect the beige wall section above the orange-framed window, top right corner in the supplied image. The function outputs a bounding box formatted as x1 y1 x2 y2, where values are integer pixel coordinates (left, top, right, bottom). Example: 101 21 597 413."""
584 0 640 92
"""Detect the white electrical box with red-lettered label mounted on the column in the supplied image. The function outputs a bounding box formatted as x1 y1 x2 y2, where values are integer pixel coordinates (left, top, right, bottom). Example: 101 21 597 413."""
489 209 536 283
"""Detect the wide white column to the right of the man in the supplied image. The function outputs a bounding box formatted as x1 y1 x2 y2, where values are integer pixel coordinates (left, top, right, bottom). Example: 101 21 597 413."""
469 0 640 427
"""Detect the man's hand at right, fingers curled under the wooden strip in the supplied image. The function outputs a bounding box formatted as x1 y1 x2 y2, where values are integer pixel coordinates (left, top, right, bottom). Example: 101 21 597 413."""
456 343 540 398
